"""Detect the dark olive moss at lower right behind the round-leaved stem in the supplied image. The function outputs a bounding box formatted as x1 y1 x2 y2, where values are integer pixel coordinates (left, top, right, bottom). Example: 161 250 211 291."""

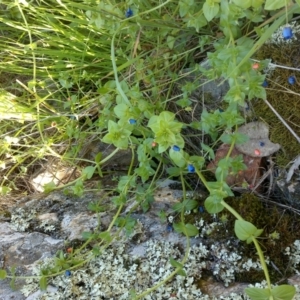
190 194 300 283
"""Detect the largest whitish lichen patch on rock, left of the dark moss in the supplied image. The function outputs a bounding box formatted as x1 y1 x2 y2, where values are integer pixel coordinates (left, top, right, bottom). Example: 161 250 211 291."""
22 240 209 300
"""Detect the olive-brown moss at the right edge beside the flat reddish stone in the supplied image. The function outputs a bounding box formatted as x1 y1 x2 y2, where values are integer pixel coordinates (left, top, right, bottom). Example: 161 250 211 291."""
252 40 300 167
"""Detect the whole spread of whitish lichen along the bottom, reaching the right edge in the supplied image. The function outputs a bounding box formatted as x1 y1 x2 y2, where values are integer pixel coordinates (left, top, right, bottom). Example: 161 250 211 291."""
22 240 300 300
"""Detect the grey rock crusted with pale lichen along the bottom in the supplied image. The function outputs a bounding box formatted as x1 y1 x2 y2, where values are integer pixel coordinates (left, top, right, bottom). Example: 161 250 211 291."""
0 182 300 300
